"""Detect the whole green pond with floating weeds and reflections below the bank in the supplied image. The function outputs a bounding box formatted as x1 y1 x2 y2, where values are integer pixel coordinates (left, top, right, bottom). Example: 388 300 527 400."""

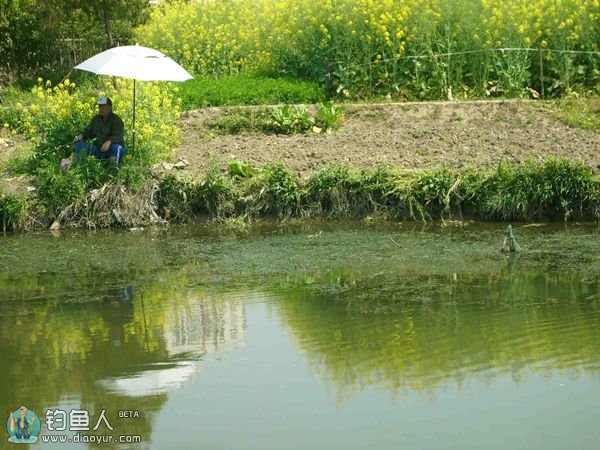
0 223 600 450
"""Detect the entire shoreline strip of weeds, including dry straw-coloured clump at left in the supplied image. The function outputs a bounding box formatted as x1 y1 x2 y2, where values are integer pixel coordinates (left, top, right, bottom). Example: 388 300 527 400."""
0 159 600 231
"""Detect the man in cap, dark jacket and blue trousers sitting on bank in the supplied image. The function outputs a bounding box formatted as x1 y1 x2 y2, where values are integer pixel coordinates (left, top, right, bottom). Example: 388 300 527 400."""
75 97 126 167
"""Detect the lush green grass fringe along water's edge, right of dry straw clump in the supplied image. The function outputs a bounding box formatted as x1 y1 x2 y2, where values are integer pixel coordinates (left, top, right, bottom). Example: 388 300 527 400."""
160 159 600 225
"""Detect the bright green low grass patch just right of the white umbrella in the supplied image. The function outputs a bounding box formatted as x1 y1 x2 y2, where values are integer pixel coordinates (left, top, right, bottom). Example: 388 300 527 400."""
177 74 325 110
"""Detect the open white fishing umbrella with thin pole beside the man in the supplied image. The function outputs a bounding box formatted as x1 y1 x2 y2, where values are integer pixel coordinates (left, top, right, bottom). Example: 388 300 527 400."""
75 45 194 152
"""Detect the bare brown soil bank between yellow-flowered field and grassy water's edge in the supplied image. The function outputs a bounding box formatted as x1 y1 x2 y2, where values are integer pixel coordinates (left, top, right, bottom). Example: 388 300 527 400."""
176 101 600 174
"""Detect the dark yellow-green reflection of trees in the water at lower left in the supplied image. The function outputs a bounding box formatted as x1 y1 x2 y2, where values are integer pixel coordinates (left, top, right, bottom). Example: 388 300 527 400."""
0 297 166 447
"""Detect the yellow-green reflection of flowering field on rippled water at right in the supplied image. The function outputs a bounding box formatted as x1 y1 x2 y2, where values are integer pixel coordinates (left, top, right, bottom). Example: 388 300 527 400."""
279 273 600 399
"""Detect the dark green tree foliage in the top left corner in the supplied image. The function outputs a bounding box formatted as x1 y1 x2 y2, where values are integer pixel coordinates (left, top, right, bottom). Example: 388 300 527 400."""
0 0 150 81
